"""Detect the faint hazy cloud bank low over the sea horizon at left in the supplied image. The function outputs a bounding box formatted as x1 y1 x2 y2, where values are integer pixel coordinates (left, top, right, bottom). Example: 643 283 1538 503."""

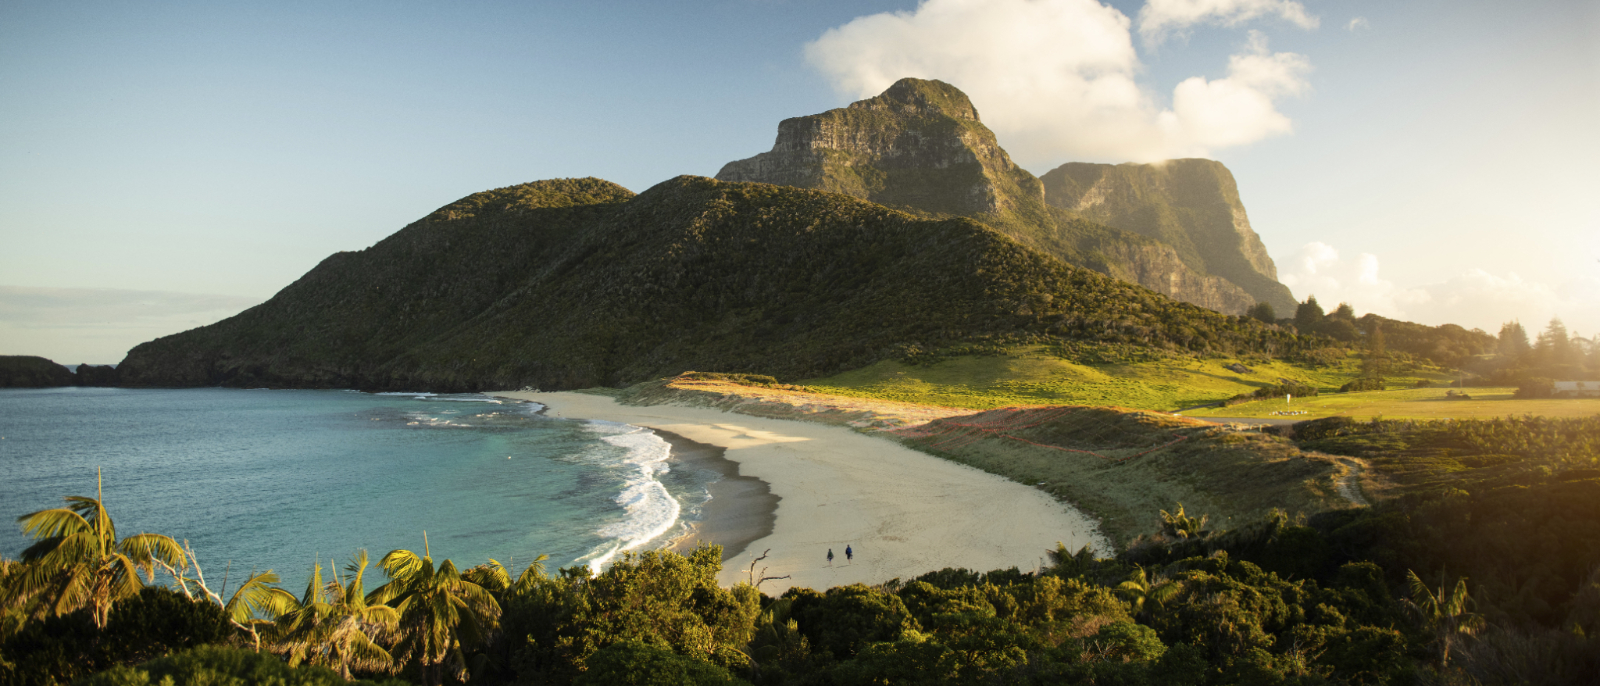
0 286 261 365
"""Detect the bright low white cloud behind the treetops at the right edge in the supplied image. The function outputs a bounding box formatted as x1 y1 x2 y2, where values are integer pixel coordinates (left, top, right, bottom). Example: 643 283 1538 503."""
1278 243 1600 336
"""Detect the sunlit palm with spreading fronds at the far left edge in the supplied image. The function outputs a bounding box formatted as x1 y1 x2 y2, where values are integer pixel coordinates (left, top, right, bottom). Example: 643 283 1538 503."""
0 470 187 628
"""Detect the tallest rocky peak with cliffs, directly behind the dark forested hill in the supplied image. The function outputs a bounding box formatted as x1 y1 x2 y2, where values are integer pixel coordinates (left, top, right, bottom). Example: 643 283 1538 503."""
717 78 1267 313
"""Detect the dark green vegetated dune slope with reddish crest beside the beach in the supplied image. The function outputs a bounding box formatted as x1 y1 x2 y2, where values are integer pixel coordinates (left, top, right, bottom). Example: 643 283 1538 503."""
894 408 1350 547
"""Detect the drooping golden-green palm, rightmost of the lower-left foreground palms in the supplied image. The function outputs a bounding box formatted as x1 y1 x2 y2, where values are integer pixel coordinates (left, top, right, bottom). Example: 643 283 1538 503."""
366 532 499 686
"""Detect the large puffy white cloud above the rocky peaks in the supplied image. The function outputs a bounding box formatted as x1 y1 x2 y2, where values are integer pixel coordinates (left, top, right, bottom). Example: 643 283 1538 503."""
805 0 1310 166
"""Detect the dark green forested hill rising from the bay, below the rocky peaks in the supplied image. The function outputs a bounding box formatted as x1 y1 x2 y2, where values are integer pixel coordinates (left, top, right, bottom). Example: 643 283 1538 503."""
117 176 1299 392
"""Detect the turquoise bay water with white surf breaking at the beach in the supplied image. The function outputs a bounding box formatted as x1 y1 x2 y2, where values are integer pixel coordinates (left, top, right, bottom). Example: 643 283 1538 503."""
0 389 717 595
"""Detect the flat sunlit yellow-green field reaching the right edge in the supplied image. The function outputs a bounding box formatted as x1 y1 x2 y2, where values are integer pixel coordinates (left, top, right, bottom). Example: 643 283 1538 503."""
1189 387 1600 419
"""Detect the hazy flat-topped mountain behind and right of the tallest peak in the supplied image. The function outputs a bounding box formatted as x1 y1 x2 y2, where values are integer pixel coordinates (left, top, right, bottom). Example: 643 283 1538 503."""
1042 160 1296 317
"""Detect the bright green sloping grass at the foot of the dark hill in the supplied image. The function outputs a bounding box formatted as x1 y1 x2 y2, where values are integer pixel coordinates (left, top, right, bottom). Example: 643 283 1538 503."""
802 347 1450 411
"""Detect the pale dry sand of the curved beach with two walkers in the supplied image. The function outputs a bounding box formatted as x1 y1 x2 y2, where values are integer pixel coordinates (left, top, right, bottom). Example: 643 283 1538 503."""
494 392 1110 595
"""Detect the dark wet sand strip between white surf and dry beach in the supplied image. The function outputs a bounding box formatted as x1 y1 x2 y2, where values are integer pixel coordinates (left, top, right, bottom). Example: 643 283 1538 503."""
651 429 781 561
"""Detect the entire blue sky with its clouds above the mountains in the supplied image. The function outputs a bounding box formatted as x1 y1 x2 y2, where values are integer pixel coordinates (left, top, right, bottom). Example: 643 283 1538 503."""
0 0 1600 363
